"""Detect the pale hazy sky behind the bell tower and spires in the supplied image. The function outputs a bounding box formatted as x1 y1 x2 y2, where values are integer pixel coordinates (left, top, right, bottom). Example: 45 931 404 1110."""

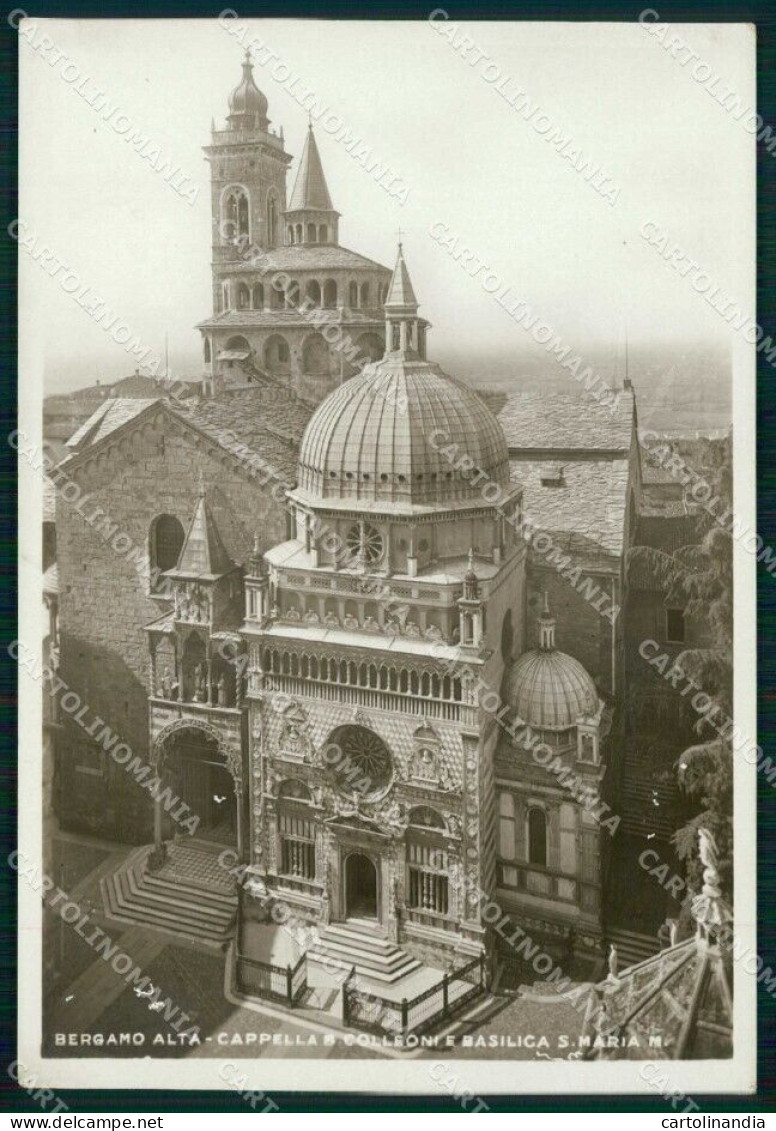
19 19 755 390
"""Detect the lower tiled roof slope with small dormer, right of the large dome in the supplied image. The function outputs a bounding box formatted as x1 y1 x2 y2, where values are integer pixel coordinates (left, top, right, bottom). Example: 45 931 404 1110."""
510 457 628 567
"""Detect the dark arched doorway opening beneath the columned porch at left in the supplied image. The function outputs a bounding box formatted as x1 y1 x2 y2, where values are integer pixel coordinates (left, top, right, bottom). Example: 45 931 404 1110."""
163 726 238 847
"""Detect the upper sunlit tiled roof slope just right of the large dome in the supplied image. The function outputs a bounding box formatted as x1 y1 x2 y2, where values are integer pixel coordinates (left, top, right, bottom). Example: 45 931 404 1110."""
499 391 633 452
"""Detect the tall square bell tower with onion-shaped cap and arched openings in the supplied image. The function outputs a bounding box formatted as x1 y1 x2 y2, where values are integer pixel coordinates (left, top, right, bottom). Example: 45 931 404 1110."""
205 51 291 314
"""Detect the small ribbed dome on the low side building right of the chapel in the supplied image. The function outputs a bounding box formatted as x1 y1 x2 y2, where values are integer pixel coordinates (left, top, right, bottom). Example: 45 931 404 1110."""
503 648 598 729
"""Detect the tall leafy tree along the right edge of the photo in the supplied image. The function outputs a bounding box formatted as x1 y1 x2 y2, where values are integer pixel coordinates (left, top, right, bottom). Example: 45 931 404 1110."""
629 438 733 901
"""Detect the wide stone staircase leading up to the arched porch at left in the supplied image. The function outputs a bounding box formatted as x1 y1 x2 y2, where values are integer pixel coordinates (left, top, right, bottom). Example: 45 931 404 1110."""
100 846 238 949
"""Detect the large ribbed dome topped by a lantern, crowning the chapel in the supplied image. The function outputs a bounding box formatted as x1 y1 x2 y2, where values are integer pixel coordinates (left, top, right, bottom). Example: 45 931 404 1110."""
299 354 509 504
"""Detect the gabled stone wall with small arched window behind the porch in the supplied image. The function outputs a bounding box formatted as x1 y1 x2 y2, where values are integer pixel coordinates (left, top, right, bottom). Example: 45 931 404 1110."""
57 407 285 839
